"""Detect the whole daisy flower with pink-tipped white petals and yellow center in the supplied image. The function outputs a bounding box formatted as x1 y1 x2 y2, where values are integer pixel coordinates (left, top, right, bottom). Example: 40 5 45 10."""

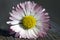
7 1 50 39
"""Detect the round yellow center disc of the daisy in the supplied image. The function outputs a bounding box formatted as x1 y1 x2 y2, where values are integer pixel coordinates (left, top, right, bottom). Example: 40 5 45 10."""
22 16 36 29
